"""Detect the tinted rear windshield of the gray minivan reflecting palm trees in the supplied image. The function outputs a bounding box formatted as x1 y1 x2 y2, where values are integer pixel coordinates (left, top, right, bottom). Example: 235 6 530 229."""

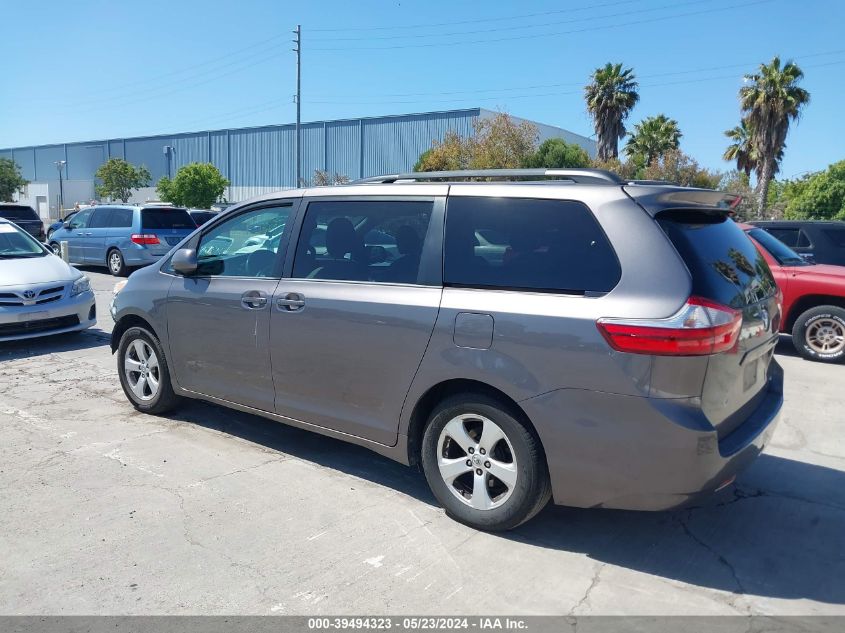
657 210 777 308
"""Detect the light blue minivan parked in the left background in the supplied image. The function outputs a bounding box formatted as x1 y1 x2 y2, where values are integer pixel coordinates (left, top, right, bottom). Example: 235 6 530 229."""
50 204 197 276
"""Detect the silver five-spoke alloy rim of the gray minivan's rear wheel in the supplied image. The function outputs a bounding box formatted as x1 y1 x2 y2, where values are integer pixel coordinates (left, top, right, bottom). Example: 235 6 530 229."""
437 413 517 510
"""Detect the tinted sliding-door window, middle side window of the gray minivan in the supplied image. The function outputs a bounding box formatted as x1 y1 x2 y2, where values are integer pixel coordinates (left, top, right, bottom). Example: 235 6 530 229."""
293 200 434 284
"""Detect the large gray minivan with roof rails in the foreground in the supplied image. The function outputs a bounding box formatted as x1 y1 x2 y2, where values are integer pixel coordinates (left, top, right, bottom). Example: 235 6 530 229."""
111 170 783 530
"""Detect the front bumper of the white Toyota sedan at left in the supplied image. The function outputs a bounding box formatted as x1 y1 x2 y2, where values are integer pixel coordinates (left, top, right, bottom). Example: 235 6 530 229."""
0 290 97 342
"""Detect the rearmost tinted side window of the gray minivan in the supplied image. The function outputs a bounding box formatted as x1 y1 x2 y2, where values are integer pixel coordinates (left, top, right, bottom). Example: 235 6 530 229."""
444 196 622 294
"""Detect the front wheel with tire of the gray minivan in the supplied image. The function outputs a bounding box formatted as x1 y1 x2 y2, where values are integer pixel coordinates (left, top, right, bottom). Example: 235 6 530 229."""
117 327 179 415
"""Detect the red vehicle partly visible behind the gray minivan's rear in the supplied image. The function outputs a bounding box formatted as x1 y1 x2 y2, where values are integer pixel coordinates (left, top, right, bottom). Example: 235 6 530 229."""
740 224 845 363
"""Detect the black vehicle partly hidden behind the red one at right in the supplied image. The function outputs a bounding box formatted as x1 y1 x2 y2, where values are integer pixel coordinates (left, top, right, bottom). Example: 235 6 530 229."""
750 220 845 266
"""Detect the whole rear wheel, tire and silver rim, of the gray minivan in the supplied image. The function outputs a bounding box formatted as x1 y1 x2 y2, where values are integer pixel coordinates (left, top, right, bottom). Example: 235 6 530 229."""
421 394 551 531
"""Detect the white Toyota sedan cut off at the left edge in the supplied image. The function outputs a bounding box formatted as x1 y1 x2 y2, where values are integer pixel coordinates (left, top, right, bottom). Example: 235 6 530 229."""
0 219 97 341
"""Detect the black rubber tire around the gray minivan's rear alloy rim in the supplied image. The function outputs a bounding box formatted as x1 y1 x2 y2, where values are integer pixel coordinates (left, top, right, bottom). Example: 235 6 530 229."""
420 393 551 532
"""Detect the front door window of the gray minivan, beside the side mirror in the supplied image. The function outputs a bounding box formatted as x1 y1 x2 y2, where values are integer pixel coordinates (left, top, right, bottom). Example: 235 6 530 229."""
197 205 291 277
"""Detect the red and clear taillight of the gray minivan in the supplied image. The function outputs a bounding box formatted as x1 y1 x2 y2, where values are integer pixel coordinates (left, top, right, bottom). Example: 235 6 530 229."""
596 296 742 356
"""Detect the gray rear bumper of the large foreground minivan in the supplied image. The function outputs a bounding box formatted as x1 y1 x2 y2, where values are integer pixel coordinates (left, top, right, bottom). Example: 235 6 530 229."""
520 361 783 510
